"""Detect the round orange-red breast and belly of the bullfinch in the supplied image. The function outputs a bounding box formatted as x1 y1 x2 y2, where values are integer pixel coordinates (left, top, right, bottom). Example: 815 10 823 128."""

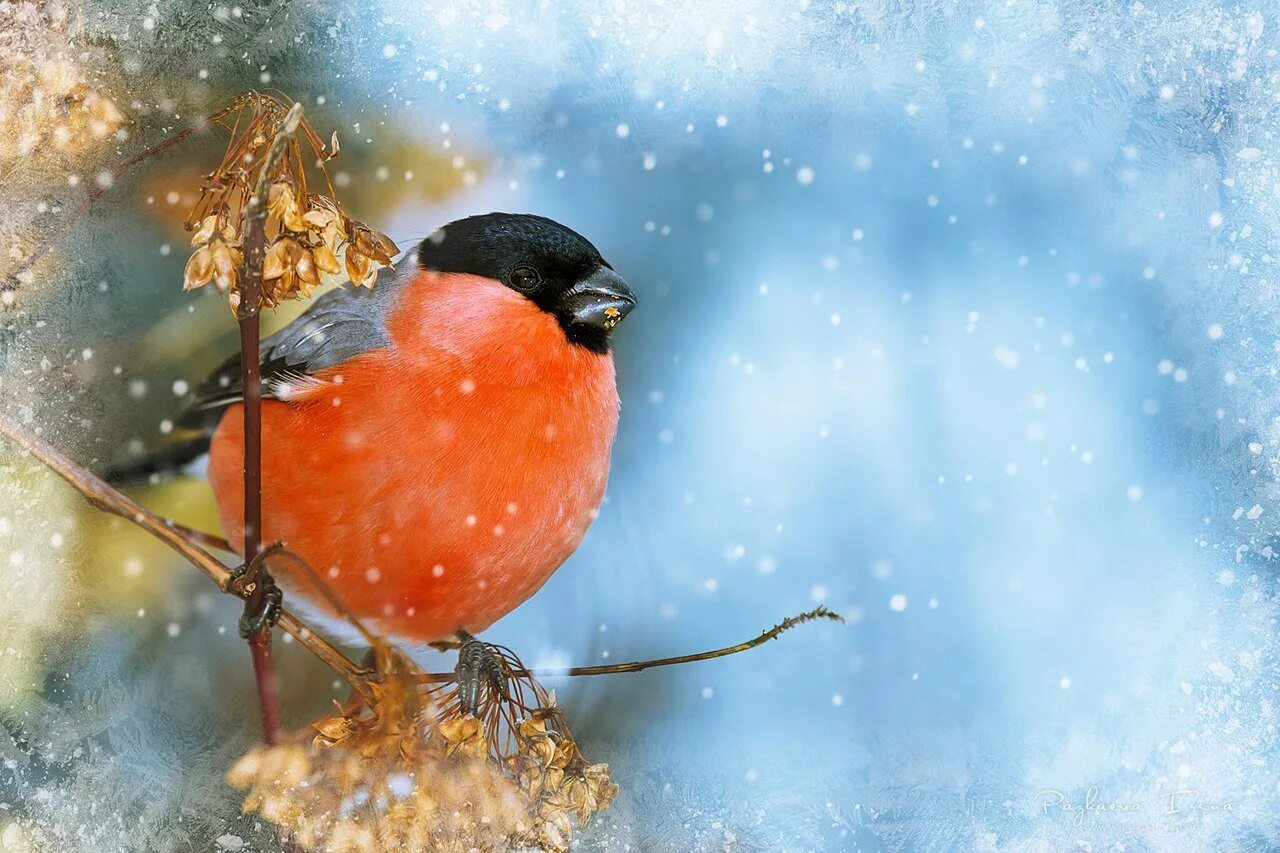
209 272 618 640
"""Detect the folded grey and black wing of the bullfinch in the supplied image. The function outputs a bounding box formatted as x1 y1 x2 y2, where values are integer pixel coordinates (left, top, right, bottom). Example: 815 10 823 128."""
178 256 413 433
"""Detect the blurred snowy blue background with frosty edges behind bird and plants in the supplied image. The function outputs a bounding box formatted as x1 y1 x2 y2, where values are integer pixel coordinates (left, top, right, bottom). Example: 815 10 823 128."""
0 0 1280 850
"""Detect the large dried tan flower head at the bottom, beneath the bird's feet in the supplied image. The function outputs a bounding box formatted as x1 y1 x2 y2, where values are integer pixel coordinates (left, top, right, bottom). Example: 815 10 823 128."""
227 647 617 853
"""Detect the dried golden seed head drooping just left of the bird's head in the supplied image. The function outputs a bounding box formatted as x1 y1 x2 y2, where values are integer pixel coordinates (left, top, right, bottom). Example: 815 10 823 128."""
183 92 399 310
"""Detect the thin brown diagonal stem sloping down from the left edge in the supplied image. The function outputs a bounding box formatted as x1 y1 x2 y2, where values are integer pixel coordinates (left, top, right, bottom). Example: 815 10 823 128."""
0 416 369 690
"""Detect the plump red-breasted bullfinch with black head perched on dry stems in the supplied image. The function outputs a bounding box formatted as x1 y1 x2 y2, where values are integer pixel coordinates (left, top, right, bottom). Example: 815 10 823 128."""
109 213 636 691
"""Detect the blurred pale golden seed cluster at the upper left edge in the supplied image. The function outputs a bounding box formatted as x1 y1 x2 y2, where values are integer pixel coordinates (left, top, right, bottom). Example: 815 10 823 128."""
0 51 125 160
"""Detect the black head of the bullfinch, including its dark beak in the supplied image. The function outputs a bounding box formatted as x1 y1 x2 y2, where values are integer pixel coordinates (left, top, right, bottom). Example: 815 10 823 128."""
417 213 636 352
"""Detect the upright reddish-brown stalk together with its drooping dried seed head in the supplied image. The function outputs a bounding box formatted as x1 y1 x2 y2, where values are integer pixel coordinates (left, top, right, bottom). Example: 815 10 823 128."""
183 92 398 744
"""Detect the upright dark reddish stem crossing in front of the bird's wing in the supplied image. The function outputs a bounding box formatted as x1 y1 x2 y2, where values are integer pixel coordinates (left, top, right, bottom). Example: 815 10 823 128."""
236 104 302 747
